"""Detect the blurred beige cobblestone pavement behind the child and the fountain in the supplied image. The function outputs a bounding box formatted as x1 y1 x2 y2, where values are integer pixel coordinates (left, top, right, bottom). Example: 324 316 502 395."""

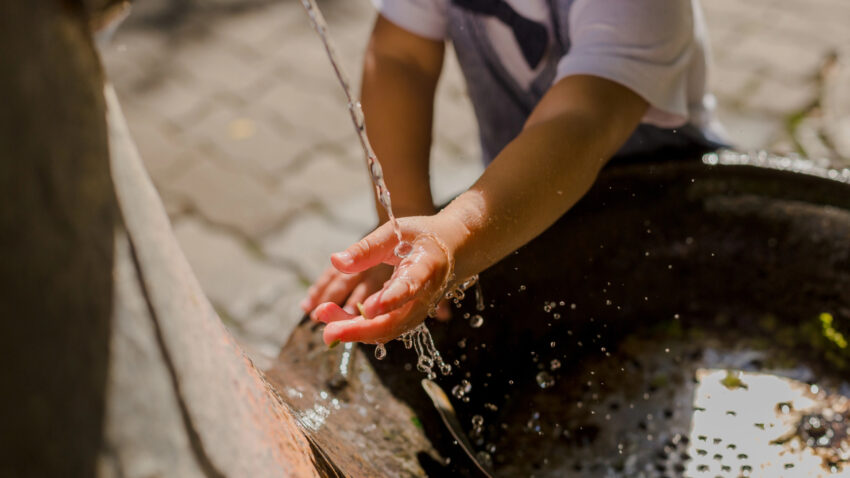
103 0 850 355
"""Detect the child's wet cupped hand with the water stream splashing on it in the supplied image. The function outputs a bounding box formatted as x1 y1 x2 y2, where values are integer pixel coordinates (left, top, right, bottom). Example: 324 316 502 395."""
312 217 453 344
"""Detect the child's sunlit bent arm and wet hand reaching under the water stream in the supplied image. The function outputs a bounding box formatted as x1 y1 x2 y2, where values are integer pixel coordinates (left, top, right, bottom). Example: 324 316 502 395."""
316 75 648 343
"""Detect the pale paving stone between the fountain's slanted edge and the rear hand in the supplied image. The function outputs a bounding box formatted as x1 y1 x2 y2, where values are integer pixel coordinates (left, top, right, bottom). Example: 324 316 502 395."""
174 218 300 324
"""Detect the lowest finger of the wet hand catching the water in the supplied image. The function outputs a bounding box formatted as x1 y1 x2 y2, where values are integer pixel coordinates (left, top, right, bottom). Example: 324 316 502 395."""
322 304 424 344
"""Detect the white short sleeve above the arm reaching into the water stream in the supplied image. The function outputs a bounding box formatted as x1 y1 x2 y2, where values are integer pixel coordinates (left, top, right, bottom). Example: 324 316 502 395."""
555 0 697 127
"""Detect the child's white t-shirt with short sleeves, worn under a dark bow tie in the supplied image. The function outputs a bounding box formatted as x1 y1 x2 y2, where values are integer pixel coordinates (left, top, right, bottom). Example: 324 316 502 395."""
373 0 725 141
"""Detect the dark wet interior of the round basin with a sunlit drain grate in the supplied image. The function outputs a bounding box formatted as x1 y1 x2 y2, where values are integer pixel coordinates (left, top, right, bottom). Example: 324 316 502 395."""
268 155 850 477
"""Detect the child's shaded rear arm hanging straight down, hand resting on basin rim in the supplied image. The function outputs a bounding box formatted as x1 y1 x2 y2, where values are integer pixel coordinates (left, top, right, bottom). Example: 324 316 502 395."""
301 17 444 318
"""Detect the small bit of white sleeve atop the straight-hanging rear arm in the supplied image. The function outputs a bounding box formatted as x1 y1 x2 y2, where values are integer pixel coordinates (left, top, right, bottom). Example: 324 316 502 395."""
372 0 449 40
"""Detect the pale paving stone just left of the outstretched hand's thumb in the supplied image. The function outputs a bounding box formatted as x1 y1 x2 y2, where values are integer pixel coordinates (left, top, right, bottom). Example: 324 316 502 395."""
262 213 360 281
